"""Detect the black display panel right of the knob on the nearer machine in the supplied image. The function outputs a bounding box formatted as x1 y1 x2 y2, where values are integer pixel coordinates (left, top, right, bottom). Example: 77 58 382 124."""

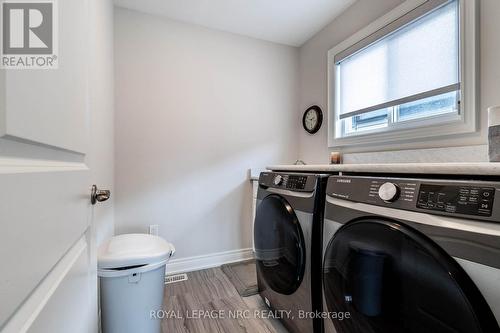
417 184 495 216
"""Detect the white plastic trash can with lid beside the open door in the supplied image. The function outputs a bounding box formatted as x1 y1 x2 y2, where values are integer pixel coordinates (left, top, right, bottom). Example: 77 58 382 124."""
97 234 175 333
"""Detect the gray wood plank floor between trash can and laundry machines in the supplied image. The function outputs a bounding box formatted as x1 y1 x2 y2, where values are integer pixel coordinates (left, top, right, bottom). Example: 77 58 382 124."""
162 268 287 333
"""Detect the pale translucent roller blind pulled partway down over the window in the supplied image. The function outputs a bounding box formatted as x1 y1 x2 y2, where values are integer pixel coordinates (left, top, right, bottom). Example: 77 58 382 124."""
338 1 460 114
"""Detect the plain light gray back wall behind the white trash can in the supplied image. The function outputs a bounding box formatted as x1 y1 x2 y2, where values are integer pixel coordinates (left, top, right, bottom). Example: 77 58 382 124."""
115 8 299 259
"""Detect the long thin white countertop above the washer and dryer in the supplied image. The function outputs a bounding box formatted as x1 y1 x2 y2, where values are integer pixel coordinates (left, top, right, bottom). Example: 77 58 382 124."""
267 162 500 176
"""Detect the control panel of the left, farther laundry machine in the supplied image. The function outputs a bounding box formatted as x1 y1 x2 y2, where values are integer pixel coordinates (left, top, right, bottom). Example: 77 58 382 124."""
259 172 316 192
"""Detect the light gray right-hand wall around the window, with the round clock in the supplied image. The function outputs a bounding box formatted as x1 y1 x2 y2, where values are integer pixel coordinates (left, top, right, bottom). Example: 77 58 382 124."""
299 0 500 163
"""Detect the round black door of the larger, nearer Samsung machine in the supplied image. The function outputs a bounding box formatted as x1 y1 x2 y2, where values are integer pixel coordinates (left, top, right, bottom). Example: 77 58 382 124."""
323 217 500 333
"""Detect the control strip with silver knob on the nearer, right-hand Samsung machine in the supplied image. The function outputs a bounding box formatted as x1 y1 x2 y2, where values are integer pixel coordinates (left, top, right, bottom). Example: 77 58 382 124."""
326 176 500 222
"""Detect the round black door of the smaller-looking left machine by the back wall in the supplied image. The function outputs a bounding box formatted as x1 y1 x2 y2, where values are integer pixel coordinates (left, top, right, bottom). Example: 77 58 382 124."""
254 194 306 295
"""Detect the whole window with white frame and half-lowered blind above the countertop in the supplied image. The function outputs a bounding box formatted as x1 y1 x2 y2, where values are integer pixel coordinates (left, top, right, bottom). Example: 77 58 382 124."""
329 0 476 146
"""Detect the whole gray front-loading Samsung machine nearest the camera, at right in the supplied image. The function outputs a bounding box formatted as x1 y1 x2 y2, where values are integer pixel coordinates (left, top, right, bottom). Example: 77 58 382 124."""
322 176 500 333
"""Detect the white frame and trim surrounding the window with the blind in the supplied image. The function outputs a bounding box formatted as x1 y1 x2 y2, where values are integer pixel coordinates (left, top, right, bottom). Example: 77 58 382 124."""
327 0 480 150
